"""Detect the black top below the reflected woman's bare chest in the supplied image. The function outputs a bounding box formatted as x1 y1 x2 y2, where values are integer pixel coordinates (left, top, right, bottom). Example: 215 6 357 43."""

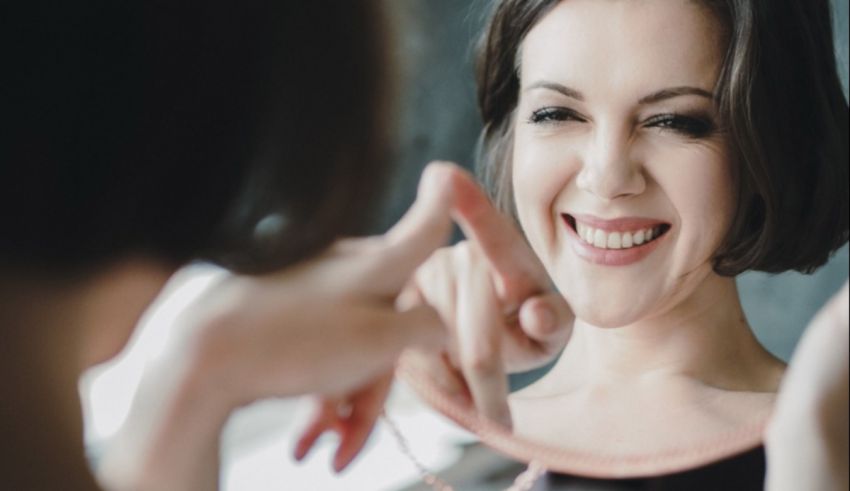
545 447 767 491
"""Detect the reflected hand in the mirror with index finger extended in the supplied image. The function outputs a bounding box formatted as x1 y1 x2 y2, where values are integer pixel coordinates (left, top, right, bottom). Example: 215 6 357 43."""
400 164 574 427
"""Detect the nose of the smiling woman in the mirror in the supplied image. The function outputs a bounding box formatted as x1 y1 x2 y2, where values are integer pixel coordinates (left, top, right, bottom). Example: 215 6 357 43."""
576 127 646 201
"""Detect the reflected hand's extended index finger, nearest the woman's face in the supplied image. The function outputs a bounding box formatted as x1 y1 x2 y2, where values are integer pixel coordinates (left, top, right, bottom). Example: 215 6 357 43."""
450 167 548 308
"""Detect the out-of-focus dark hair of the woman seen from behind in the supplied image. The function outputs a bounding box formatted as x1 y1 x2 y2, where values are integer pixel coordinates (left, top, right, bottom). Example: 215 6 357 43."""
0 0 387 274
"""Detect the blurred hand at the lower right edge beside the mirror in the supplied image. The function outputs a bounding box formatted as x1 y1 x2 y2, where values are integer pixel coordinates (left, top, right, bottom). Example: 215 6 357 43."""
765 283 850 491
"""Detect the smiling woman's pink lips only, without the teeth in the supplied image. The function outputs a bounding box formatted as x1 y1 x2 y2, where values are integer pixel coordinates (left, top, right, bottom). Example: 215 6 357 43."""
562 214 670 266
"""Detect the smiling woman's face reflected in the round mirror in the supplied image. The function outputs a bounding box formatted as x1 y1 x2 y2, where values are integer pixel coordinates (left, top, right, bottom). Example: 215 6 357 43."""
513 0 733 327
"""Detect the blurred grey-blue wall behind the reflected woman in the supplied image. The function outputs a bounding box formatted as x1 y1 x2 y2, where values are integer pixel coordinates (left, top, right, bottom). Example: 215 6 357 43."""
382 0 848 366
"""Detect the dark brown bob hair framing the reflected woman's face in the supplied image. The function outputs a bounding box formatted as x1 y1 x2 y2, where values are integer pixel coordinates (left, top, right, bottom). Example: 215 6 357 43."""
477 0 850 276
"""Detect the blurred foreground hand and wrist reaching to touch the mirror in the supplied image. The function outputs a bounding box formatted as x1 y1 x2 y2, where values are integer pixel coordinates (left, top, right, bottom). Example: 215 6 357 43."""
99 165 458 490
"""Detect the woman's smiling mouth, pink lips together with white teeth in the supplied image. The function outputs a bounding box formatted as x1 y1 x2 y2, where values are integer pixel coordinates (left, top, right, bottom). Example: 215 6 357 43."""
562 213 671 266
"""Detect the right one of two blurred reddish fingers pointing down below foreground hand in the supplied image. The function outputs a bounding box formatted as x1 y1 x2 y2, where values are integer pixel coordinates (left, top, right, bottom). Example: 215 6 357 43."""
333 372 393 472
